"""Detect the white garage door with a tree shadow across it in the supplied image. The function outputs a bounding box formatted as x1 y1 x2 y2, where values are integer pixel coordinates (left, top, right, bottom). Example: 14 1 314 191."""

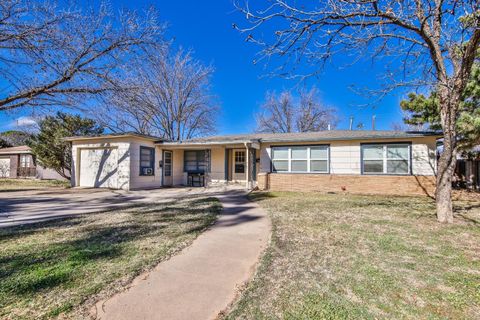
80 148 118 189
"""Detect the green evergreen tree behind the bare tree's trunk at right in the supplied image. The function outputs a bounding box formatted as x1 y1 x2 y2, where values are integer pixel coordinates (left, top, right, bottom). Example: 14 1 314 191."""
400 60 480 151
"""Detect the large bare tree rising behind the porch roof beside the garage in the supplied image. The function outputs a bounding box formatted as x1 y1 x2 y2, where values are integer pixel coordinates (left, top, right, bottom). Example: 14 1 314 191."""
97 49 219 141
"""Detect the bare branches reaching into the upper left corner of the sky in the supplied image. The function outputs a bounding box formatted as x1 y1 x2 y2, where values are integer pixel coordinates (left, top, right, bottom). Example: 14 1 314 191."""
0 0 162 111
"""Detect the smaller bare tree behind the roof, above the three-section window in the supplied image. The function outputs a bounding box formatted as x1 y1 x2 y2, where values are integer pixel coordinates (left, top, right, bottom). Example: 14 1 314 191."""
256 88 338 133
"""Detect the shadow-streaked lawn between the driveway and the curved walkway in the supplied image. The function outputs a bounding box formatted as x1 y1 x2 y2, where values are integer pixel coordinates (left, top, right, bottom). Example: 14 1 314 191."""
0 197 221 319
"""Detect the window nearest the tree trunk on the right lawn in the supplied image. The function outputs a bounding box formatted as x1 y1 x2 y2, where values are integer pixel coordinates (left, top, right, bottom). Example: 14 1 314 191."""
362 143 411 174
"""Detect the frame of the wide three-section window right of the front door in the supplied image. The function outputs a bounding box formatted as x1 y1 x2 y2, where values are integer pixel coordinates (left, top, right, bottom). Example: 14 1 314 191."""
270 143 331 174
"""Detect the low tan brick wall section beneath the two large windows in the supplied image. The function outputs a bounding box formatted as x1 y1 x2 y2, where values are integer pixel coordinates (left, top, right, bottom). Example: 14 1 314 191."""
257 173 435 196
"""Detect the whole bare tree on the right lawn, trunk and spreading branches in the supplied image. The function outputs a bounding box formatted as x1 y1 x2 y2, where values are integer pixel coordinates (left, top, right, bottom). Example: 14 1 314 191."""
237 0 480 222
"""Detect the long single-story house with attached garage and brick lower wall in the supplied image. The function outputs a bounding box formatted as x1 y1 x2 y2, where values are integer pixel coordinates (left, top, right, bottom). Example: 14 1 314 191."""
66 130 440 195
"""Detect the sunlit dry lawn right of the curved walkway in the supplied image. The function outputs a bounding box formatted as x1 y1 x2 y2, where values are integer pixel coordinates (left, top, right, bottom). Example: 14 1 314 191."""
226 193 480 319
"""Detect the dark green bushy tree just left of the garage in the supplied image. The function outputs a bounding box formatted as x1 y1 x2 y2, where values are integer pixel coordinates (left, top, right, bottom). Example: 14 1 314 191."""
28 112 104 179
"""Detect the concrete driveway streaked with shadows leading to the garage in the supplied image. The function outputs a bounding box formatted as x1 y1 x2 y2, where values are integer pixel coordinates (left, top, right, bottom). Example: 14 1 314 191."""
0 188 222 228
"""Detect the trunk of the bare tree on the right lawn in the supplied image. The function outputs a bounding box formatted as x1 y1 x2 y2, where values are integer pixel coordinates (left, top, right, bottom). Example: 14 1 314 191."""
435 87 460 223
